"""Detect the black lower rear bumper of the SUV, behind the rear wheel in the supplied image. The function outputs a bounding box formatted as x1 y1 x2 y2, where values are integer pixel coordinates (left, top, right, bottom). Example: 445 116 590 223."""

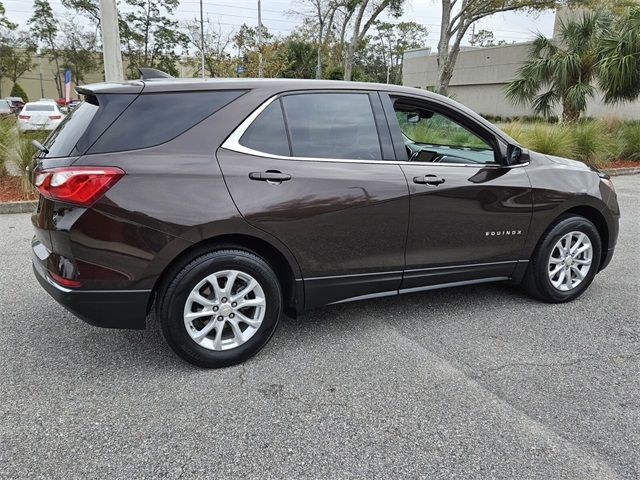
33 255 151 330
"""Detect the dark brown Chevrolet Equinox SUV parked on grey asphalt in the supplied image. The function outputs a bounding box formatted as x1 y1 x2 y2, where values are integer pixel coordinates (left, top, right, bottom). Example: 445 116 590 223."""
33 75 619 367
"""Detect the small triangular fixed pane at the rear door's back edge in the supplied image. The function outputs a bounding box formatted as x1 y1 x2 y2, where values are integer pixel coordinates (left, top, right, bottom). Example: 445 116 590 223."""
240 100 291 156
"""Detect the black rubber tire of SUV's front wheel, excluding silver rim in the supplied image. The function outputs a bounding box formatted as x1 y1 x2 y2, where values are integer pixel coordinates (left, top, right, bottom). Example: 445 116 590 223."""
522 215 602 303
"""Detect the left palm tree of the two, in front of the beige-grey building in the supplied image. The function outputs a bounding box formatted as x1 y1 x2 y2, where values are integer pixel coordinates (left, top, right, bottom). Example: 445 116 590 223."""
506 12 608 122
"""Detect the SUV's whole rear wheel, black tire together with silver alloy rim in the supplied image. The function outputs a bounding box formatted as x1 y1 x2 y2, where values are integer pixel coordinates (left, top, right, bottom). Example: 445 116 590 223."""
156 249 282 368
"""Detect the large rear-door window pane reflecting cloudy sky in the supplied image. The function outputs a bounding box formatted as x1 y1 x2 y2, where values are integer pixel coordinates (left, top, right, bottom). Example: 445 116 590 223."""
282 93 382 160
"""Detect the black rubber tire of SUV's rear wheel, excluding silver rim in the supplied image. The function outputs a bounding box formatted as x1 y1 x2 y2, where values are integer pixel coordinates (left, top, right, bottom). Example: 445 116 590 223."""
156 249 282 368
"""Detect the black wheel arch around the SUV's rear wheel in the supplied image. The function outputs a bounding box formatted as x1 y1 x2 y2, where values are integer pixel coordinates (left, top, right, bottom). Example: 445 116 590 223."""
147 233 304 317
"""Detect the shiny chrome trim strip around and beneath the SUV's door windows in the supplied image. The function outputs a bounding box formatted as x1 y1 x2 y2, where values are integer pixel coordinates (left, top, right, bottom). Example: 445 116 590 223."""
220 90 529 168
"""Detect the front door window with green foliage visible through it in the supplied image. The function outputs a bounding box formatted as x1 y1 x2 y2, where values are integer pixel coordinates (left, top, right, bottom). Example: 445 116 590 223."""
394 102 495 164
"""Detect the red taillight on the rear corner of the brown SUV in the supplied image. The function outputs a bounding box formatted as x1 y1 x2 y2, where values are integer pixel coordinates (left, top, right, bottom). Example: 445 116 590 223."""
34 167 125 207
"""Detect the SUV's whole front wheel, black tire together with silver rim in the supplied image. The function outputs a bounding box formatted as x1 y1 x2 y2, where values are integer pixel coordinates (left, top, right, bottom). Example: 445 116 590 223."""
522 215 602 303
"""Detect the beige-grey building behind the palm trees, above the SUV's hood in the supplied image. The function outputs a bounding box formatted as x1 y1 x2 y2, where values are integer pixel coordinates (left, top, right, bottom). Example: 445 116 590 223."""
402 10 640 119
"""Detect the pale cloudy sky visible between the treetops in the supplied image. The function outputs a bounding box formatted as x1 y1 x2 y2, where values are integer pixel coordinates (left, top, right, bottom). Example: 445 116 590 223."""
1 0 554 50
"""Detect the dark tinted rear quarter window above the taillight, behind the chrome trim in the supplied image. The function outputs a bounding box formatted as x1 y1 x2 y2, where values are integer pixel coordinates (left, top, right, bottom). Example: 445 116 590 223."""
87 90 244 153
